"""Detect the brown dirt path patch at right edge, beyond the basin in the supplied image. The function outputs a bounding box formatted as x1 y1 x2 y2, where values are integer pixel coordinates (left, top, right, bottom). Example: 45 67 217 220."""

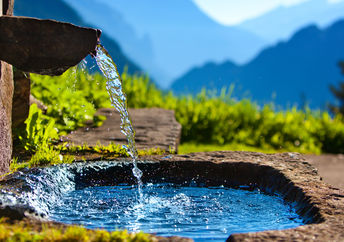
305 154 344 189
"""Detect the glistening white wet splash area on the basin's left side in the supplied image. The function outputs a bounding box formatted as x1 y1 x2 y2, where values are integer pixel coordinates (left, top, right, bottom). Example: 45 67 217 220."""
0 164 75 216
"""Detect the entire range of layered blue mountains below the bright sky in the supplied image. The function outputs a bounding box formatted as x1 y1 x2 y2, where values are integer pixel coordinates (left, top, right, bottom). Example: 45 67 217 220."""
15 0 344 107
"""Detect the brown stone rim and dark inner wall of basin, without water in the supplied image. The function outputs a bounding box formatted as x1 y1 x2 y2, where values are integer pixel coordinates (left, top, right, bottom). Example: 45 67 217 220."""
0 152 344 241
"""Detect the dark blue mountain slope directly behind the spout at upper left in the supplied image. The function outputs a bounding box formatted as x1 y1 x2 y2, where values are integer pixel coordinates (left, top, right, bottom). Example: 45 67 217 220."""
14 0 141 73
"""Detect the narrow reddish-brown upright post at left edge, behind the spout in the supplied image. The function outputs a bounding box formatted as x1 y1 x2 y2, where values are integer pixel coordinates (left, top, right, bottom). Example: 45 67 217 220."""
0 0 14 175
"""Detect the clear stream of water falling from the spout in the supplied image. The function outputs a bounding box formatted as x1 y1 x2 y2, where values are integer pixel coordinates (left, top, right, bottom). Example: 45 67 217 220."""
95 44 142 187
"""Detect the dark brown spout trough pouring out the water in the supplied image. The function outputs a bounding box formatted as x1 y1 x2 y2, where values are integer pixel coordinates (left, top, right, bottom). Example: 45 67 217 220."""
0 16 101 75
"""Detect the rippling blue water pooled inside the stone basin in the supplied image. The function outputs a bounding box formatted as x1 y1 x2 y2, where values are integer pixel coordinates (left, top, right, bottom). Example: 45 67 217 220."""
50 184 303 241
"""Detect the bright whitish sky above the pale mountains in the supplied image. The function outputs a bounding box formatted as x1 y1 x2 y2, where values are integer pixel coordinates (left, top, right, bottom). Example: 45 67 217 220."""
193 0 343 25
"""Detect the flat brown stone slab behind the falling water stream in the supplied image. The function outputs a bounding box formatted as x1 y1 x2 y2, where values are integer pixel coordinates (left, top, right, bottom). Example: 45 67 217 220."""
62 108 181 151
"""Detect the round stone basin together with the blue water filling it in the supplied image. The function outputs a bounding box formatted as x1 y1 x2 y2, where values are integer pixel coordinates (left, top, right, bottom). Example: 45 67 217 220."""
0 152 344 241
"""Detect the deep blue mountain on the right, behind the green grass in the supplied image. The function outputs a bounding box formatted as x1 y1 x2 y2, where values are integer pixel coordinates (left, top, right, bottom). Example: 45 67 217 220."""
172 20 344 108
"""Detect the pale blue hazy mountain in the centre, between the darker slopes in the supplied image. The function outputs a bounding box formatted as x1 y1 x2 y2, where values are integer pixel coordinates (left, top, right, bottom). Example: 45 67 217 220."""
65 0 266 87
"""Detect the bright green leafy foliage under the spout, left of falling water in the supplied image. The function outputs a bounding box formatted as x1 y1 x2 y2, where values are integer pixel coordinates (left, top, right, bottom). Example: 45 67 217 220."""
31 68 110 134
